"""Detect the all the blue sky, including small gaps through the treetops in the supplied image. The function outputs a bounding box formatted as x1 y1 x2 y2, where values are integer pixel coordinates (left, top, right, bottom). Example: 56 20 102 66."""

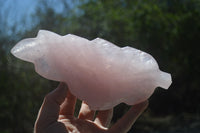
0 0 73 34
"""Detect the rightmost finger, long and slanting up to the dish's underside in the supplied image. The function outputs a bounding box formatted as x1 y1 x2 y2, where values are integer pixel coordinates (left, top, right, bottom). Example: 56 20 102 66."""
110 101 148 133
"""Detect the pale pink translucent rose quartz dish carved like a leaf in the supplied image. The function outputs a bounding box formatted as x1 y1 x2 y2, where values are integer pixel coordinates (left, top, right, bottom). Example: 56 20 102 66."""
11 30 172 110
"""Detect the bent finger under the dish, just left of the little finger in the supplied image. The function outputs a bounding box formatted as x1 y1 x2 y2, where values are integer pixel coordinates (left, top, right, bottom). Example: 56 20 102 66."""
94 109 113 127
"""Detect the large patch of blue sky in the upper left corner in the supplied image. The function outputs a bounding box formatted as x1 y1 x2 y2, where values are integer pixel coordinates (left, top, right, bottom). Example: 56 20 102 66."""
0 0 37 34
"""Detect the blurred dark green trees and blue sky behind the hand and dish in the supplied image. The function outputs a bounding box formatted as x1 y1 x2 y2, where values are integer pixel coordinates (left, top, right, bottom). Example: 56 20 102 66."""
0 0 200 133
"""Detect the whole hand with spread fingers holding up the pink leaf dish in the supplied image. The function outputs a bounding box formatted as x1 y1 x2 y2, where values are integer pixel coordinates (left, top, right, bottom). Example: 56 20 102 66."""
34 83 148 133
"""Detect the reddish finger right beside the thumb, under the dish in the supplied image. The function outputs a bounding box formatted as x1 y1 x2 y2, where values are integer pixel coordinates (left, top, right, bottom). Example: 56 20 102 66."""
59 89 76 118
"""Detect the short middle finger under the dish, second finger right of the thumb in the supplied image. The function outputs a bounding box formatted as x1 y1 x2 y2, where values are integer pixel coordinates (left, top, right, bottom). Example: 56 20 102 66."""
78 102 95 121
